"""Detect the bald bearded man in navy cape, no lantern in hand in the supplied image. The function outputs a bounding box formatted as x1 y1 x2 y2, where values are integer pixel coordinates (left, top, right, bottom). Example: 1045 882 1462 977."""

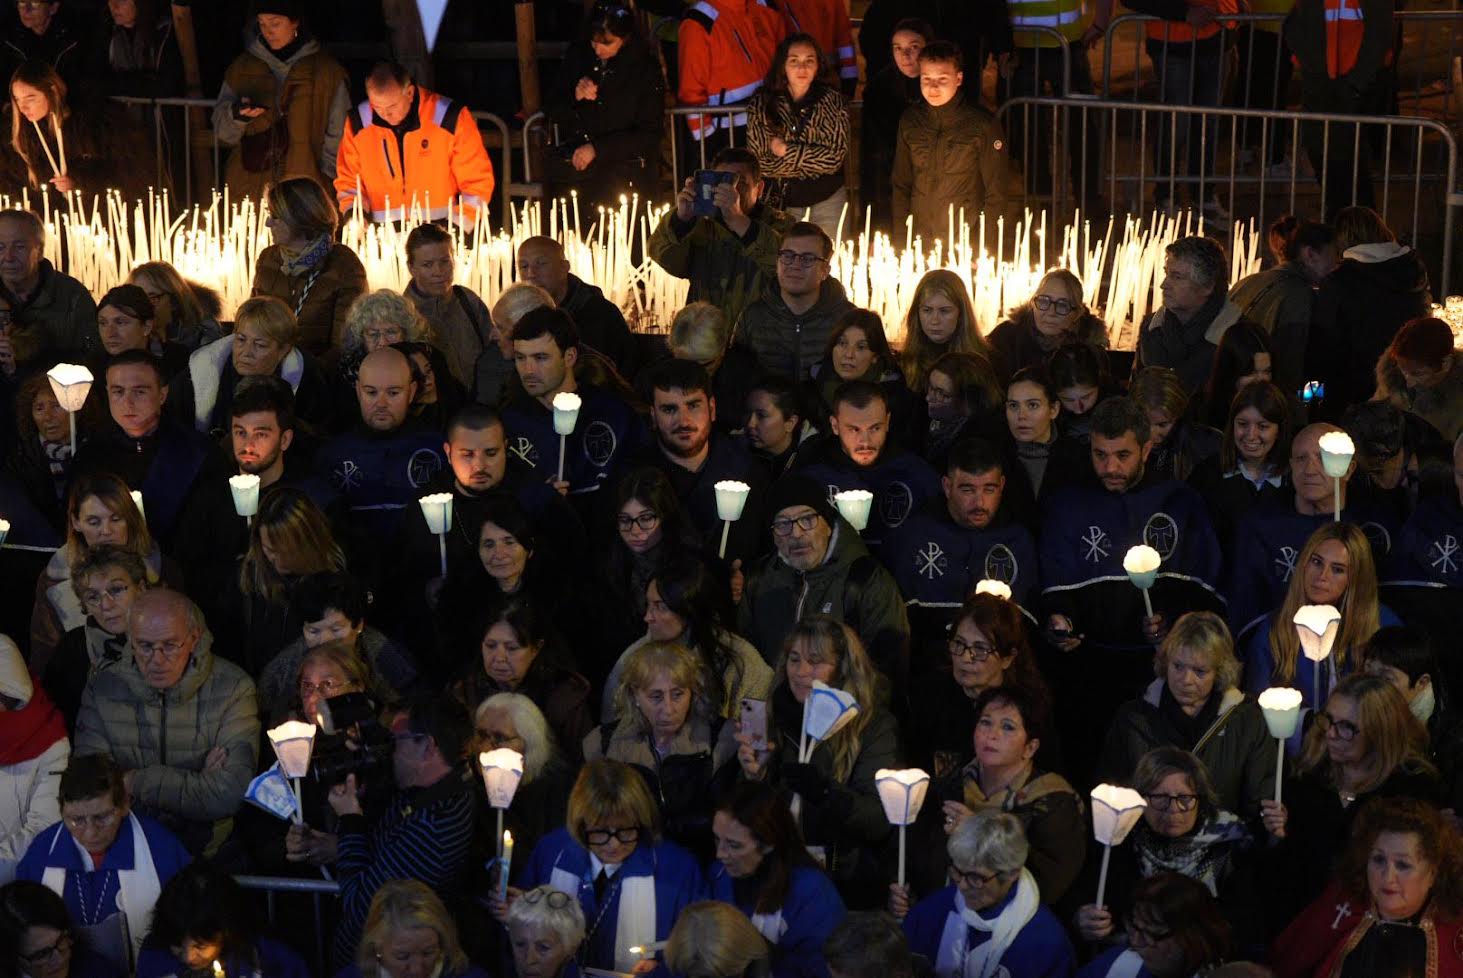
315 347 446 546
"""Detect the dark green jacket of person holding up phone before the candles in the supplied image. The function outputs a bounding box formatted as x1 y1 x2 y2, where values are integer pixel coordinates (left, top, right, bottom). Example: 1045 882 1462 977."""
649 205 790 325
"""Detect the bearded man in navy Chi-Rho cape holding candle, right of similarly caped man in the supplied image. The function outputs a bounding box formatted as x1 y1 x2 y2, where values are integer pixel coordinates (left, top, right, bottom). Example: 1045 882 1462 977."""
1040 397 1223 783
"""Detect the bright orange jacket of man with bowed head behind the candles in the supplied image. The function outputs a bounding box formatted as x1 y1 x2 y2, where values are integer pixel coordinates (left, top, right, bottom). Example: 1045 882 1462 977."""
335 86 493 227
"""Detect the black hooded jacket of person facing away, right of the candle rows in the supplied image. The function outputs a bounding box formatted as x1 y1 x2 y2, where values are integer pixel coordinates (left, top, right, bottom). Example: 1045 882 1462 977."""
1305 242 1432 408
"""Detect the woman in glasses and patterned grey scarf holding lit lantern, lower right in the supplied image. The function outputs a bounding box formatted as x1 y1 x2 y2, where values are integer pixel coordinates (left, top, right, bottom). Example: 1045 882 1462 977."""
1074 747 1254 941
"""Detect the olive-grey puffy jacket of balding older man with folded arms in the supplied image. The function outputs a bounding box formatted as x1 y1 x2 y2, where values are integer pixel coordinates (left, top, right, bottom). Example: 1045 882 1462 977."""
76 631 259 852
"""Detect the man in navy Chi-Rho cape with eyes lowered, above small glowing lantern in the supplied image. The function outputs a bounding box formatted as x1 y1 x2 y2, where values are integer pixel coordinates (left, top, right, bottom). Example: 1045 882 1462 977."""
885 438 1039 675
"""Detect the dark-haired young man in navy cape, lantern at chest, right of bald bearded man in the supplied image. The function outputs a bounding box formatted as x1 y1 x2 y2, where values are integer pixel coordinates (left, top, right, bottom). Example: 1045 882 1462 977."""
503 307 644 496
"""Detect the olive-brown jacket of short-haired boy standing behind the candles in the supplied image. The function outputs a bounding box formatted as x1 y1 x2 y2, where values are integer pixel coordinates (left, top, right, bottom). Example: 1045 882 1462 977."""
891 94 1008 249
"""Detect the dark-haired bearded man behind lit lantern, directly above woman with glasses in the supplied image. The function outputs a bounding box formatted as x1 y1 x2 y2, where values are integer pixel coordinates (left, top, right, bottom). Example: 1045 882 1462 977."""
629 359 768 561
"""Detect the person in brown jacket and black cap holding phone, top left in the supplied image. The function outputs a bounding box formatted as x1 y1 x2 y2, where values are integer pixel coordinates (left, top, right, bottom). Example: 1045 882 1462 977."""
214 0 351 199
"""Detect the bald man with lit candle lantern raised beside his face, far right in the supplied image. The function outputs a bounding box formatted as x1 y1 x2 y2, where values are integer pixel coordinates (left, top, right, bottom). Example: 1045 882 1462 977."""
1227 425 1400 644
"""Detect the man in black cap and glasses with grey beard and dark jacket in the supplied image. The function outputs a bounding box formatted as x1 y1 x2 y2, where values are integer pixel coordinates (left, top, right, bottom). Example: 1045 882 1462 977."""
737 474 909 690
